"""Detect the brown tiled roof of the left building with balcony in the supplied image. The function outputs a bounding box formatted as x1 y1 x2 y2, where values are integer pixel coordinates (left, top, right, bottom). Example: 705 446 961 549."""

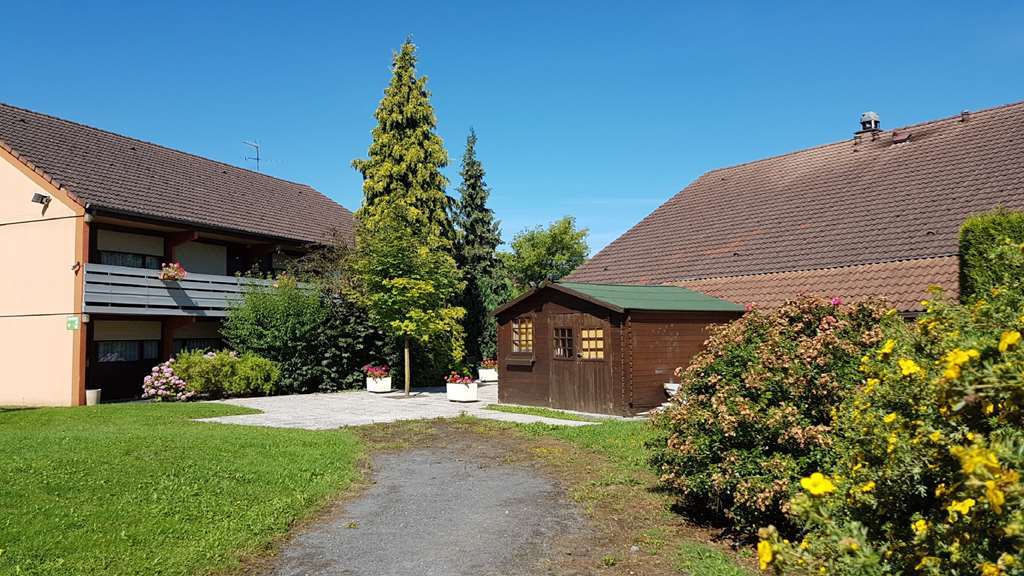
0 104 353 242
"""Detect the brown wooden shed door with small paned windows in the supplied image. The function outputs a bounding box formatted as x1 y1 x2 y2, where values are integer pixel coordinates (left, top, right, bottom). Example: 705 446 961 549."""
549 313 615 414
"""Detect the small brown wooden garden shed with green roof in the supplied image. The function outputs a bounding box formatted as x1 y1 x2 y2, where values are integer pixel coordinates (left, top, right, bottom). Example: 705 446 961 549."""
495 282 743 415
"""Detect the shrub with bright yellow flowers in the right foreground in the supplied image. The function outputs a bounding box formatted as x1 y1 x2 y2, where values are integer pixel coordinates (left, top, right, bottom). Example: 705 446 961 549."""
759 244 1024 576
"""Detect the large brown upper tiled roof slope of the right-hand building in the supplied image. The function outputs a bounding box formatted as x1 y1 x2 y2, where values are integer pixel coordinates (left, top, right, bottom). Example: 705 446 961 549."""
566 102 1024 309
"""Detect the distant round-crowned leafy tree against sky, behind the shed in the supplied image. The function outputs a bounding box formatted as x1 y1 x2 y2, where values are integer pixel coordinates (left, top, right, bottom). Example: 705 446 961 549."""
506 216 590 290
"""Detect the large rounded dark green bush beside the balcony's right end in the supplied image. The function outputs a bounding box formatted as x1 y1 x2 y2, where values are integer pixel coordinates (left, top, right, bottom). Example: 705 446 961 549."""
221 278 386 394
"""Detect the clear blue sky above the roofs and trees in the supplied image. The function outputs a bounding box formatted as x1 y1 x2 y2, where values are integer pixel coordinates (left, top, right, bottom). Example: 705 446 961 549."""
0 0 1024 250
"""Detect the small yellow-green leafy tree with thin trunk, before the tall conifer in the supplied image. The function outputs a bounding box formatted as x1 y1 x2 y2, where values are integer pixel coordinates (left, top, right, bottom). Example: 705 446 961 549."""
351 201 465 395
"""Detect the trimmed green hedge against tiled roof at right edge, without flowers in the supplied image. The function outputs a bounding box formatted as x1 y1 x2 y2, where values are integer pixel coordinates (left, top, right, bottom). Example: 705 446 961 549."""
959 210 1024 301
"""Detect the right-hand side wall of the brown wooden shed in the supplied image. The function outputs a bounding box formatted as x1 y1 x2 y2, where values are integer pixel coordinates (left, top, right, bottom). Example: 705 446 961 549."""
626 312 739 413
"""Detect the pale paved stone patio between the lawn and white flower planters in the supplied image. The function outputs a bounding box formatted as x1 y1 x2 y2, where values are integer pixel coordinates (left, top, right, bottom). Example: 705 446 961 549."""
196 384 591 430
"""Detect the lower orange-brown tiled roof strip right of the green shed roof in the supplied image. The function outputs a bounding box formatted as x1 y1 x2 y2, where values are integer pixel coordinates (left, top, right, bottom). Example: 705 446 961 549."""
679 256 959 312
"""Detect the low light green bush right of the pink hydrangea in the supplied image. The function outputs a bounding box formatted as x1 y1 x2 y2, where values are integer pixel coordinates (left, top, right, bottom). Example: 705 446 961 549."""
173 351 281 398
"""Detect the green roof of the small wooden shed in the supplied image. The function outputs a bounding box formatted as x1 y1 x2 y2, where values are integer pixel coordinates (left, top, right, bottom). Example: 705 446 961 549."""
557 282 743 312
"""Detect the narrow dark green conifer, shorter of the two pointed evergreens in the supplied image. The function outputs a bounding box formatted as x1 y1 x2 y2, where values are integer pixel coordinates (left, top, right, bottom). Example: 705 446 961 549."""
454 130 502 362
